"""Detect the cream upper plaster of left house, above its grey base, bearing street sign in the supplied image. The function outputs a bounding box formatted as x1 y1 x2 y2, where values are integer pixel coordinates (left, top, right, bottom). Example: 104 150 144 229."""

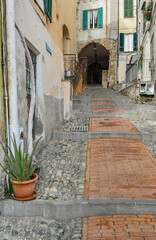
15 0 63 99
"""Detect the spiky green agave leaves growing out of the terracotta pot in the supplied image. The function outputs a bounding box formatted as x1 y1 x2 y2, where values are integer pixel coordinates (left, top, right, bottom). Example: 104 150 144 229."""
0 135 42 182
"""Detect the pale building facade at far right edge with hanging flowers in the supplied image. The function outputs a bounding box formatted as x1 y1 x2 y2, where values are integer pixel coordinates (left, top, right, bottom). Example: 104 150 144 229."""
138 0 156 91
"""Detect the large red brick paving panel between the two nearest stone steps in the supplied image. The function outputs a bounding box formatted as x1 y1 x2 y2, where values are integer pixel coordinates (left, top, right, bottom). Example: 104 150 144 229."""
84 139 156 199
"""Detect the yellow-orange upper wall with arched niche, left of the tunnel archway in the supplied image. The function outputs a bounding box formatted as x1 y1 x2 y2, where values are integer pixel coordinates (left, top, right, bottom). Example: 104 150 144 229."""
31 0 76 53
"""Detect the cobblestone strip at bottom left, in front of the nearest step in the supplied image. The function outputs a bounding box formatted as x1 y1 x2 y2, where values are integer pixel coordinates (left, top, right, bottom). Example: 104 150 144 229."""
0 217 82 240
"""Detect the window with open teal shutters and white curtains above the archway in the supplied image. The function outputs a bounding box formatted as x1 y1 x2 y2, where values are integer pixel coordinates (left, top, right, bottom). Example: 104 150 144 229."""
82 8 103 30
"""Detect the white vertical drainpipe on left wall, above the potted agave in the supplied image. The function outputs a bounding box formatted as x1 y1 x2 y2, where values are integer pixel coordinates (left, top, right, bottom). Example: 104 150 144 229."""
6 0 19 149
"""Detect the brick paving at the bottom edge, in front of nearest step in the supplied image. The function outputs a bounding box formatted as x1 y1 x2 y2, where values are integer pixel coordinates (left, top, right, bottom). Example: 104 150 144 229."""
82 215 156 240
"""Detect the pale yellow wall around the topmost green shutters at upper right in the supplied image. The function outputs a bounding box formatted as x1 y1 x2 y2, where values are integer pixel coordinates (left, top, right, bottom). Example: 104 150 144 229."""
119 0 136 33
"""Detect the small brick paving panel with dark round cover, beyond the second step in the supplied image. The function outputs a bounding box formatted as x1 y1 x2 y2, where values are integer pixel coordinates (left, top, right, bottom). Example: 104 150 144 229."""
89 117 137 133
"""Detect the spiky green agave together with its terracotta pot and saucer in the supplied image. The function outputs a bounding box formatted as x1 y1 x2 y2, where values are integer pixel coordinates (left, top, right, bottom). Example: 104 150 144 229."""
0 135 41 201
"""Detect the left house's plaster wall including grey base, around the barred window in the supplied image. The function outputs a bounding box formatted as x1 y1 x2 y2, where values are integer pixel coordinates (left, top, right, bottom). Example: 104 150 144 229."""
15 0 64 140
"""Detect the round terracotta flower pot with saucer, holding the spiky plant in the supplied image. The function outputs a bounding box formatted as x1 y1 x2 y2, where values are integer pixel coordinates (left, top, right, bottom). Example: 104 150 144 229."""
10 173 38 201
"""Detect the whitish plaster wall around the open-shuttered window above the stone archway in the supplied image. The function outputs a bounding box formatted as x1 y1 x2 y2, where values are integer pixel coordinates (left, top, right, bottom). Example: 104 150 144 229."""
77 0 118 42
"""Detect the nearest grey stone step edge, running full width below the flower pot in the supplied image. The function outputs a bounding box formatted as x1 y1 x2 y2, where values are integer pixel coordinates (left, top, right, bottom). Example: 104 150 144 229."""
1 199 156 220
